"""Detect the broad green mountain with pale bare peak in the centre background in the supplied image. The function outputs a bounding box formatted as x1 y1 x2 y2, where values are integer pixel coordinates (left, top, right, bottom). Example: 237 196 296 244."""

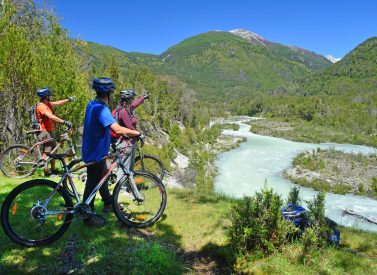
78 29 331 100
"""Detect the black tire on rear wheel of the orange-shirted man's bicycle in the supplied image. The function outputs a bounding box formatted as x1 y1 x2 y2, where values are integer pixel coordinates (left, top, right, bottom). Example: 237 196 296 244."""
0 144 37 179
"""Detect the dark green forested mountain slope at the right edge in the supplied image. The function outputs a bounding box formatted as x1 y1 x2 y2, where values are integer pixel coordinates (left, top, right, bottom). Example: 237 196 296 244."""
299 37 377 95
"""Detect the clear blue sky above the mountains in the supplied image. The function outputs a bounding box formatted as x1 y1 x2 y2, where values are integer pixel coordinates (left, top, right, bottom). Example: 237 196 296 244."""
51 0 377 57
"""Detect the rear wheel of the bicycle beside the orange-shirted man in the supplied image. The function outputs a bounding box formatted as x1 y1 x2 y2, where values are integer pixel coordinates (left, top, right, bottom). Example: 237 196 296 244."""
0 144 38 178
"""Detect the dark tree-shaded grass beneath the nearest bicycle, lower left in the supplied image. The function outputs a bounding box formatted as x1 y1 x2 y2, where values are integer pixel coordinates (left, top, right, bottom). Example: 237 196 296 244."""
0 181 184 274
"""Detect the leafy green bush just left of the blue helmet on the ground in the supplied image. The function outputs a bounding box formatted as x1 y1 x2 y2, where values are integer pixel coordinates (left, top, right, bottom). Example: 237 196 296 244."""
227 188 293 255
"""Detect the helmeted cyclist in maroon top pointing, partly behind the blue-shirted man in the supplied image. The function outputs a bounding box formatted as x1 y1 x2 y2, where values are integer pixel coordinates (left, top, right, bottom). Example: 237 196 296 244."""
111 89 149 174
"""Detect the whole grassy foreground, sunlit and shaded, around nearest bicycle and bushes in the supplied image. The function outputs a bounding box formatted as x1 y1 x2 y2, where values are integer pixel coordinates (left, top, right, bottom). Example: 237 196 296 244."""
0 176 377 274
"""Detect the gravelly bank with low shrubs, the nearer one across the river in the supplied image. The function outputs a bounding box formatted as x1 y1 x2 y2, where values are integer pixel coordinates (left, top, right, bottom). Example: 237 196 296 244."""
284 149 377 198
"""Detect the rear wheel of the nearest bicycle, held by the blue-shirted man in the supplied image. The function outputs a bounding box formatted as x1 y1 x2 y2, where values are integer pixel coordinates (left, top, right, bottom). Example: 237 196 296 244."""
1 179 73 247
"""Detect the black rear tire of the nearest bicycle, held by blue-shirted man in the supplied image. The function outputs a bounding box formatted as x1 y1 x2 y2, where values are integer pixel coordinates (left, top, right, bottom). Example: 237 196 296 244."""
1 179 73 247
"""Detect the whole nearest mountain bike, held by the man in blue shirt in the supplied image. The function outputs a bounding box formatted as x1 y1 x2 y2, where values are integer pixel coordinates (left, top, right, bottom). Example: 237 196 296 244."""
1 137 167 247
